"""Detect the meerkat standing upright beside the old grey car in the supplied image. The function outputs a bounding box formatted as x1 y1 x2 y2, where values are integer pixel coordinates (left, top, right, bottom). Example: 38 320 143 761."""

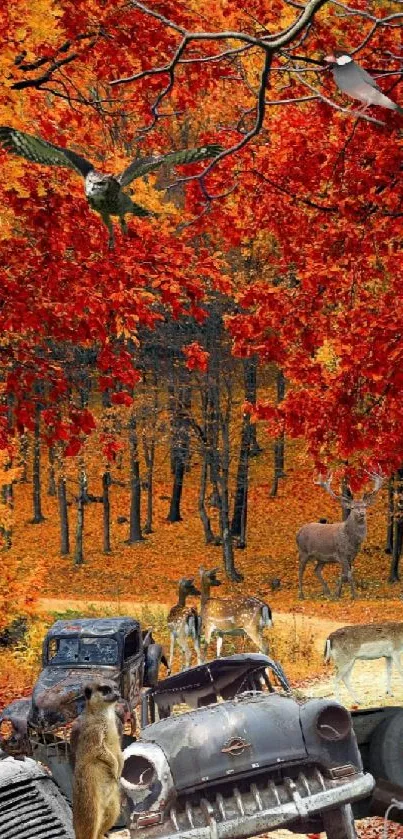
73 681 123 839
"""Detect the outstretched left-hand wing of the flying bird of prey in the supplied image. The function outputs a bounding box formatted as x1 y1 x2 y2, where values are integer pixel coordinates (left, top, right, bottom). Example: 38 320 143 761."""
0 125 94 178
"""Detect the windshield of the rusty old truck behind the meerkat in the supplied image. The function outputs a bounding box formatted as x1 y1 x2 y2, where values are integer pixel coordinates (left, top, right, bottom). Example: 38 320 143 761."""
48 635 118 665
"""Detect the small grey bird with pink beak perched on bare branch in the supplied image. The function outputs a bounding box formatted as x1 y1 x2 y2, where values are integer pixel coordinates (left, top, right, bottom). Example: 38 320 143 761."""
324 52 403 114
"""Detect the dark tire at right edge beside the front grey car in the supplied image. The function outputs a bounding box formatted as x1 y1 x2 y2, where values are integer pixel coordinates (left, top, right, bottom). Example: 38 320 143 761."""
368 709 403 786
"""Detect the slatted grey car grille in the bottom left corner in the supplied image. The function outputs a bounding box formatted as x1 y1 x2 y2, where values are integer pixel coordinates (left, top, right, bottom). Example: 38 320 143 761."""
0 764 74 839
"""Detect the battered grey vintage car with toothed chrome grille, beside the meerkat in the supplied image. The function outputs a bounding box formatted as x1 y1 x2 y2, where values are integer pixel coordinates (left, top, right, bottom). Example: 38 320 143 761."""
121 655 374 839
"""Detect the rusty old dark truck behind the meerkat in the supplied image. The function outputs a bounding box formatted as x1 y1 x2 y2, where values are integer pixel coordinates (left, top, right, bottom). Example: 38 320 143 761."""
0 617 164 769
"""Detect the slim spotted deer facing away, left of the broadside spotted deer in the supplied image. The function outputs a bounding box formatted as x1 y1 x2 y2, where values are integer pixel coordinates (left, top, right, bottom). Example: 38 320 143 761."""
167 577 201 669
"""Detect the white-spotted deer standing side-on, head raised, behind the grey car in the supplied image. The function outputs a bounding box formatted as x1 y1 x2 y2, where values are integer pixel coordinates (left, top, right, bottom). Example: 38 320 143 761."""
200 568 272 658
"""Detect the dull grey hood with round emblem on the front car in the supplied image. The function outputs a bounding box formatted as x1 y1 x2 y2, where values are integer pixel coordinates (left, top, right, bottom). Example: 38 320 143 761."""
141 694 307 792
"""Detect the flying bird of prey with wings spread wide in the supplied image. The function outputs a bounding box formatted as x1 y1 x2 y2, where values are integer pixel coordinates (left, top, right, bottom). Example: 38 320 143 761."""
0 125 222 248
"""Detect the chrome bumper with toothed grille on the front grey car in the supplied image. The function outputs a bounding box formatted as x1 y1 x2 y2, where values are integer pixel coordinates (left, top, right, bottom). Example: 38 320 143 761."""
132 769 375 839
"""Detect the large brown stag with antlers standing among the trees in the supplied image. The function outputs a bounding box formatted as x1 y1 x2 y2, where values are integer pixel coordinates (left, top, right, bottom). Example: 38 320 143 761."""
297 474 385 599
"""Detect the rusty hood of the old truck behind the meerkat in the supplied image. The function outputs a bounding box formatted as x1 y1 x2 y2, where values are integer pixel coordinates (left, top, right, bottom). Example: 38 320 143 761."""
29 667 119 726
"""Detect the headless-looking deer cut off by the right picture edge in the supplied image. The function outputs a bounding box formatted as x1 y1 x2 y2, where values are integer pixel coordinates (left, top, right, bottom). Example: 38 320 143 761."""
324 623 403 702
